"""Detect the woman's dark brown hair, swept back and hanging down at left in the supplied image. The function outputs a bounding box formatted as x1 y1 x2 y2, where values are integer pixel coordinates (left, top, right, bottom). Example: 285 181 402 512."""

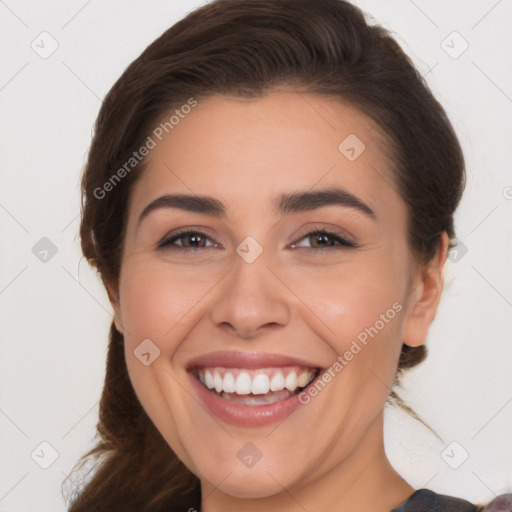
64 0 464 512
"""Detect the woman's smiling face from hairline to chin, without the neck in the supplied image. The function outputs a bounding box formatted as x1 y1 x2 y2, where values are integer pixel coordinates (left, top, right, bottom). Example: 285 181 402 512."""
111 91 437 497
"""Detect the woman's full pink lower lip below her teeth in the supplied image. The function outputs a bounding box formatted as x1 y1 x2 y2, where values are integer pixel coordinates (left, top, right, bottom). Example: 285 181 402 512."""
189 373 316 427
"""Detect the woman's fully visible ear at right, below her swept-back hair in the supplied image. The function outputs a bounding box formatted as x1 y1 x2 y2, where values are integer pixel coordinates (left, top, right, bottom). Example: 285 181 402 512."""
403 232 450 347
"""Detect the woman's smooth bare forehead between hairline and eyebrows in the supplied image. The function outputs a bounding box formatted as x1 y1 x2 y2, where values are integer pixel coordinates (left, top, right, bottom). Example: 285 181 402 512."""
131 91 399 218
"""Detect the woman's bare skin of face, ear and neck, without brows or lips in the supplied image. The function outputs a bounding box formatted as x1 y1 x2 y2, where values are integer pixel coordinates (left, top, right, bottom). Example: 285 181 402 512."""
109 90 448 512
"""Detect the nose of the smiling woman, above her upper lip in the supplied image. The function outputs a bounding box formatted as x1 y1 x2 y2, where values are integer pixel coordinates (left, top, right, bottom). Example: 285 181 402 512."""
211 255 290 340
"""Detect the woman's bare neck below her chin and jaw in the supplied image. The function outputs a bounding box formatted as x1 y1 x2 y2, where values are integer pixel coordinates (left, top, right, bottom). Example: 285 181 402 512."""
201 412 415 512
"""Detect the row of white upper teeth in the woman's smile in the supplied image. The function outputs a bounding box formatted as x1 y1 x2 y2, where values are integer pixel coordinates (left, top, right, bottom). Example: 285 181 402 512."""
198 367 316 395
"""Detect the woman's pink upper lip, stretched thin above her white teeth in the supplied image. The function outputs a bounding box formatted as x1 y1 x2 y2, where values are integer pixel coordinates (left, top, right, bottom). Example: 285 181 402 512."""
186 350 321 371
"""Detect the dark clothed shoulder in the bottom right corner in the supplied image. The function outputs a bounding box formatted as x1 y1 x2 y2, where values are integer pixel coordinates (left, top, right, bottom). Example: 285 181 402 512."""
390 489 512 512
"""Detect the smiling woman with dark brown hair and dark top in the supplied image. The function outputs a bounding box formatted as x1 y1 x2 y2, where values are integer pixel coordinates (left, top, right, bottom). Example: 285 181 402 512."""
69 0 510 512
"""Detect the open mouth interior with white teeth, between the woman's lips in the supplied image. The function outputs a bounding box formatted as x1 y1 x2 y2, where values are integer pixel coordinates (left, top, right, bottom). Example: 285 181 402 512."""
192 366 320 406
